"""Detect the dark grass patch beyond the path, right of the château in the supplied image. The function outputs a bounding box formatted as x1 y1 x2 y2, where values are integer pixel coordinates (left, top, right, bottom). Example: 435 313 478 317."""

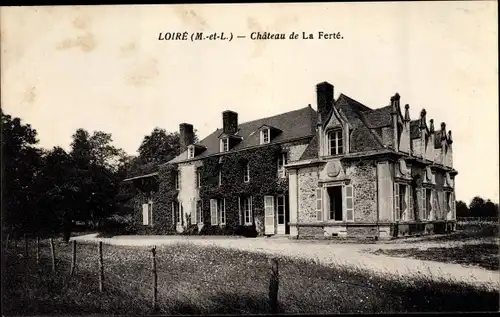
374 222 500 271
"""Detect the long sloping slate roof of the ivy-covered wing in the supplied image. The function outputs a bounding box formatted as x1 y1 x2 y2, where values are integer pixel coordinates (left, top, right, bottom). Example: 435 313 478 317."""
168 106 317 163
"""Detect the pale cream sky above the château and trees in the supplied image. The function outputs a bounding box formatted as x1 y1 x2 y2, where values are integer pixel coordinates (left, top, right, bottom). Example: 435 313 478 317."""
0 1 499 202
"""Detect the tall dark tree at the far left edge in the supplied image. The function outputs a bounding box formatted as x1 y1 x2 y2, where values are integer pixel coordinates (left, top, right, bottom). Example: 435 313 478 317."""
1 111 42 234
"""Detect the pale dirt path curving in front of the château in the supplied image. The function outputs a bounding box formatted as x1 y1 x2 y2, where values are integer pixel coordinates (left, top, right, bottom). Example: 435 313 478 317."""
72 234 500 289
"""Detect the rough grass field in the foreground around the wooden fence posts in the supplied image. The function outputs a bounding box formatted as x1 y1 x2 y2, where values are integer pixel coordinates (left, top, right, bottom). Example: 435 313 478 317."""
2 241 499 315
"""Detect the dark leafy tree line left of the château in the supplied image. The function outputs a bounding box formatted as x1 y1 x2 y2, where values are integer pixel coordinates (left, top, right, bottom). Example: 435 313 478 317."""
1 111 196 237
